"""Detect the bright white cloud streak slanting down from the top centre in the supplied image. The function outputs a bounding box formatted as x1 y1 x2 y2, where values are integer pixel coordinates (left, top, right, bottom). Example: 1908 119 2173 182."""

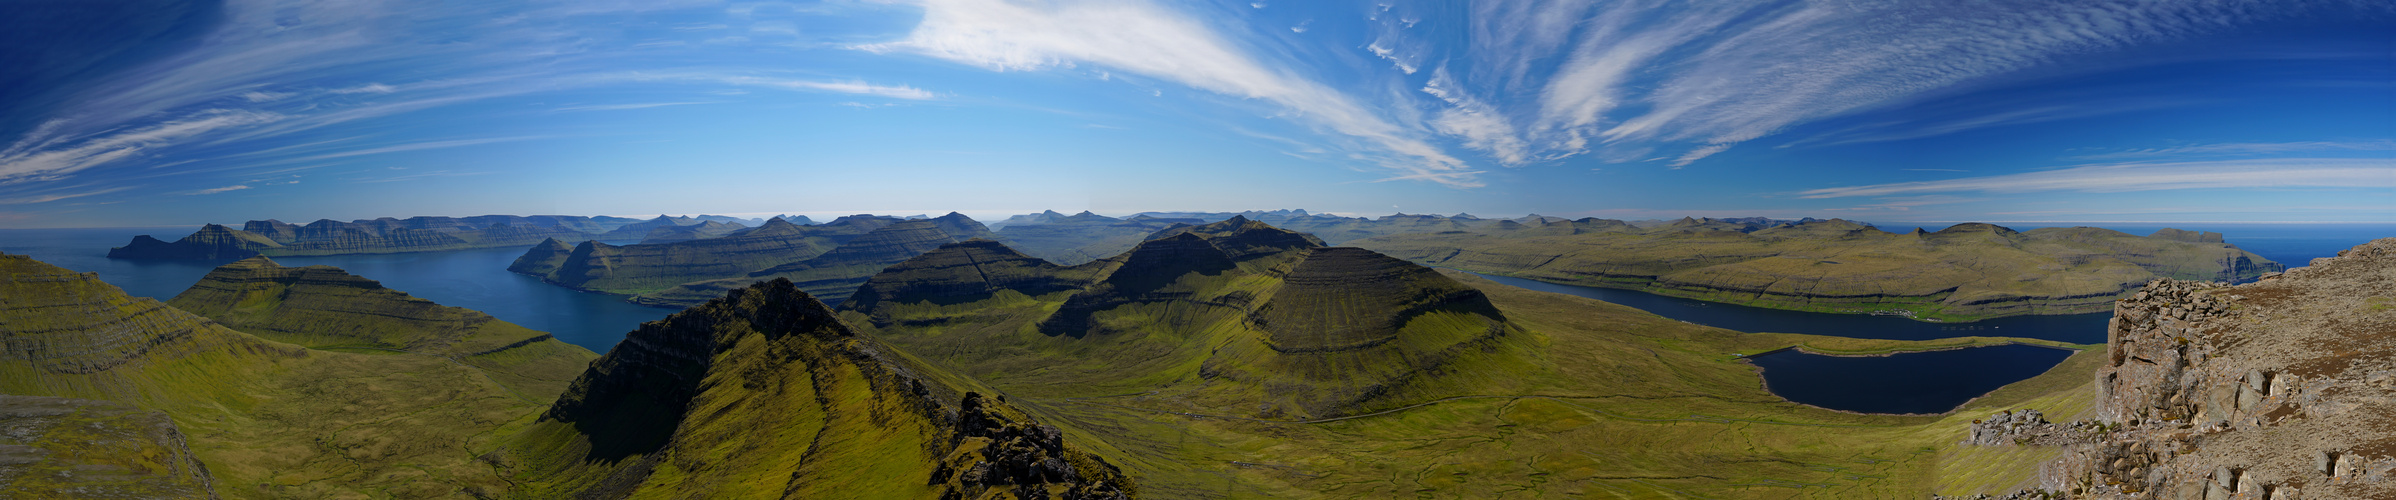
860 0 1478 187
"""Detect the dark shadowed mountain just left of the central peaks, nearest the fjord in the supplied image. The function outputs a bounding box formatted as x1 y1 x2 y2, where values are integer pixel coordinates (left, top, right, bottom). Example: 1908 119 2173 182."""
839 239 1112 325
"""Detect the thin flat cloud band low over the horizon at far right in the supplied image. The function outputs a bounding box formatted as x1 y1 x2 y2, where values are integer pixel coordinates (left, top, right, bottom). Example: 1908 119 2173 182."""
1797 158 2396 199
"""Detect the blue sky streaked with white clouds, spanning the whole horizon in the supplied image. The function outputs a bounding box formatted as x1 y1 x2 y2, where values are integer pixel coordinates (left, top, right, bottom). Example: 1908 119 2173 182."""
0 0 2396 227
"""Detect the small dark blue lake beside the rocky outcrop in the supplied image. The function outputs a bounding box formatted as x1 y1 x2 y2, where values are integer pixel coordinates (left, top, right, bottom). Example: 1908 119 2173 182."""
1747 344 2073 414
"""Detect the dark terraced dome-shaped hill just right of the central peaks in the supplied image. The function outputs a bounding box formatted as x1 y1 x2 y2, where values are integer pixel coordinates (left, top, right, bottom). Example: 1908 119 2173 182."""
1248 246 1505 352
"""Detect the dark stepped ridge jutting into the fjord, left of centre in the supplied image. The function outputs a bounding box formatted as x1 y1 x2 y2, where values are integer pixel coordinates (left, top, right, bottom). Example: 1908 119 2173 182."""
510 215 896 294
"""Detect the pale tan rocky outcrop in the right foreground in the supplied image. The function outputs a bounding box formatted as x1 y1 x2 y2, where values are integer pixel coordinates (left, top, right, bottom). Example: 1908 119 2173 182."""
2044 239 2396 500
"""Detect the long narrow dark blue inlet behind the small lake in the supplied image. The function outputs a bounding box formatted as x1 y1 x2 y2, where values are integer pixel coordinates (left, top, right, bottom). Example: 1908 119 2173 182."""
1476 273 2113 344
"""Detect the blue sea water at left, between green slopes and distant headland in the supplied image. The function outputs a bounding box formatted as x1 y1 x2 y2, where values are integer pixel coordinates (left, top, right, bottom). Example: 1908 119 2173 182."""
0 227 678 352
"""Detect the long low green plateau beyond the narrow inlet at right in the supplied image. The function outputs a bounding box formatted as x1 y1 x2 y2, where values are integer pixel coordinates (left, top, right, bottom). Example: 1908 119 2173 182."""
1354 218 2281 321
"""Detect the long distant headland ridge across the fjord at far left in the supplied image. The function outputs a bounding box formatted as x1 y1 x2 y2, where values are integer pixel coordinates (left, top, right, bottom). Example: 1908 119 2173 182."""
108 215 635 261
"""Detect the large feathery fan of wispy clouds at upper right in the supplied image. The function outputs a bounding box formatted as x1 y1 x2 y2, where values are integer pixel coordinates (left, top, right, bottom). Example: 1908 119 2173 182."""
1371 0 2389 165
